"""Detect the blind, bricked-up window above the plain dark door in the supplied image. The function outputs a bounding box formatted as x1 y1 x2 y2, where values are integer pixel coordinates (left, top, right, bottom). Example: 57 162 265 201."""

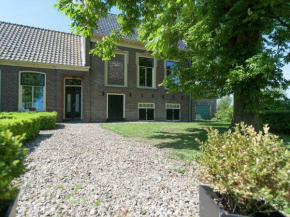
105 51 128 86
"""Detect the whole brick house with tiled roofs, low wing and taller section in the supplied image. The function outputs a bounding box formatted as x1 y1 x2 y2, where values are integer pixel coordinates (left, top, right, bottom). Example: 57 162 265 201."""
0 14 216 122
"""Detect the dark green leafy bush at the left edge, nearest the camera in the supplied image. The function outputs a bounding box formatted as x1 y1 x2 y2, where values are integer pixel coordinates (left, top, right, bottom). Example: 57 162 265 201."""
0 130 27 213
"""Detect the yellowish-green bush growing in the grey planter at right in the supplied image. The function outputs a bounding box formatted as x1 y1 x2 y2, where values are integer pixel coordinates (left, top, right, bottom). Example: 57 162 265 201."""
197 123 290 215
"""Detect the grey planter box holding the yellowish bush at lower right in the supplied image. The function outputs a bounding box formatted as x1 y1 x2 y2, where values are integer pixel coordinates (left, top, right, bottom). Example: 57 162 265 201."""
199 185 286 217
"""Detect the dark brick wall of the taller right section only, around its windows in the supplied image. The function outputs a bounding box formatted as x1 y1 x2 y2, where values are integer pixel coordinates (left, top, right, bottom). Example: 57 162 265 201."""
91 45 189 122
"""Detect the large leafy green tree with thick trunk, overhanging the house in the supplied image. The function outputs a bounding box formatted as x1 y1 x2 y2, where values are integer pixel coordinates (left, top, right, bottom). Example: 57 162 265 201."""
56 0 290 130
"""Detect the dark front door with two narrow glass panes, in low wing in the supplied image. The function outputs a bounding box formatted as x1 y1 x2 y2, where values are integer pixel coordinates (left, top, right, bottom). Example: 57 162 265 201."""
65 87 81 121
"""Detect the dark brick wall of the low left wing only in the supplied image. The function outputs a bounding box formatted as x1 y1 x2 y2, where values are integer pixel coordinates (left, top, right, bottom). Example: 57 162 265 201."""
0 65 90 121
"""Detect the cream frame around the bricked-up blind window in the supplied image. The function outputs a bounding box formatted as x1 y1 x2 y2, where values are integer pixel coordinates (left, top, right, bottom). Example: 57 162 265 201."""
105 50 129 87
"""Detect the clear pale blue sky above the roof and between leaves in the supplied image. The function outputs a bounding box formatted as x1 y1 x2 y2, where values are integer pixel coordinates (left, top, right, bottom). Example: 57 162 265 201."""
0 0 290 97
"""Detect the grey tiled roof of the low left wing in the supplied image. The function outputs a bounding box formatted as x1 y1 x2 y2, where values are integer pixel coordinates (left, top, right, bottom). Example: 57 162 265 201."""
0 22 85 66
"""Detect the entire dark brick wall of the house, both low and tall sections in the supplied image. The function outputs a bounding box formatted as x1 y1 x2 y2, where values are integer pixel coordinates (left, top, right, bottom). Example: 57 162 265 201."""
0 44 216 122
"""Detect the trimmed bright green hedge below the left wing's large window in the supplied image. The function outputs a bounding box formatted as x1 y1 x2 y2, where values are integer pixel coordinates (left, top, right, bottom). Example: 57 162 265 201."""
0 112 57 141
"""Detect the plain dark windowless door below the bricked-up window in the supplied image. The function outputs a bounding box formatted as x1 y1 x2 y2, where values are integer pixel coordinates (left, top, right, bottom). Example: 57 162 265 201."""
108 95 124 121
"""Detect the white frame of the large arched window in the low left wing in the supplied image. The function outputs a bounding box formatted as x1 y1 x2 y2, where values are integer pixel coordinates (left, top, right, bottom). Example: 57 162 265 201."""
18 71 46 111
